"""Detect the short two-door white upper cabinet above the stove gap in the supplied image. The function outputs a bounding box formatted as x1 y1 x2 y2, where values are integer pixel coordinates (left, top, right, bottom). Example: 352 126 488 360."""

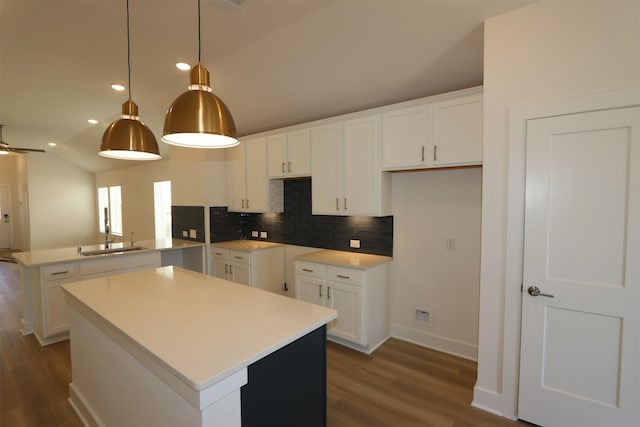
267 129 311 178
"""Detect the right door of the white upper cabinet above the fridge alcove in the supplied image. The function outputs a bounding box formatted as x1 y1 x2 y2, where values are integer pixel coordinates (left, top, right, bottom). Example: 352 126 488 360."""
431 93 482 167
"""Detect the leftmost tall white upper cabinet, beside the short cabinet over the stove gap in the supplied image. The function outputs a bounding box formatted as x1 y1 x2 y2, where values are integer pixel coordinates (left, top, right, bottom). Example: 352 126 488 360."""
227 137 284 213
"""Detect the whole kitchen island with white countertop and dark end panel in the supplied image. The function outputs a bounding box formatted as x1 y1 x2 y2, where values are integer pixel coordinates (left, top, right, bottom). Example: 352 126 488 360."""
62 266 336 426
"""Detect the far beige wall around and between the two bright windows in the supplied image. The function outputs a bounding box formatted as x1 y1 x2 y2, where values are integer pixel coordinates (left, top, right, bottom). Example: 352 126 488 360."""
94 160 174 241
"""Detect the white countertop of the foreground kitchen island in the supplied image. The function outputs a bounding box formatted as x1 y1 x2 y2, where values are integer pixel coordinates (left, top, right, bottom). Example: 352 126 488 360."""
62 266 337 390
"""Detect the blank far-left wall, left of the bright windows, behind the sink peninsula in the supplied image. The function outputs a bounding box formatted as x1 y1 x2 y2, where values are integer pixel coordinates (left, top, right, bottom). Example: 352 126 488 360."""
27 154 96 250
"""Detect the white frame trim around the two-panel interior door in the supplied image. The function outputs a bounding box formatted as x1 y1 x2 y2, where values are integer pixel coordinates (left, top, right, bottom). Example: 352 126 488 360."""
500 86 640 419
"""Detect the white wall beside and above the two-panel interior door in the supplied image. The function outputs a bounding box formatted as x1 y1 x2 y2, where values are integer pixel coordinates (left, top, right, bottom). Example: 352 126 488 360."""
473 1 640 417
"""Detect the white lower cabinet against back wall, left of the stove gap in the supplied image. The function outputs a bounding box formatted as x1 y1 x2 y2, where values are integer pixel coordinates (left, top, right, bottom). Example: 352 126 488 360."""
211 244 288 295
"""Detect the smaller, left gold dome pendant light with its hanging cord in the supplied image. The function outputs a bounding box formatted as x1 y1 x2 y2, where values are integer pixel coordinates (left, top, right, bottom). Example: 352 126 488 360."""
98 0 160 160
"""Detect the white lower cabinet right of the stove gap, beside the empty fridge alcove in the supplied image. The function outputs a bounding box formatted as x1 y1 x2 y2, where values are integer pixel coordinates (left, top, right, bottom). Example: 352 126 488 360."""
295 260 390 353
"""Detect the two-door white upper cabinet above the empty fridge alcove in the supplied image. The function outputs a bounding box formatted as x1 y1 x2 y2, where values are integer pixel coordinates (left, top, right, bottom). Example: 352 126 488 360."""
382 88 482 170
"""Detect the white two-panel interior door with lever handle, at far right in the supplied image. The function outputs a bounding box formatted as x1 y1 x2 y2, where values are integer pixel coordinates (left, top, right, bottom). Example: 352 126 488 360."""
518 107 640 427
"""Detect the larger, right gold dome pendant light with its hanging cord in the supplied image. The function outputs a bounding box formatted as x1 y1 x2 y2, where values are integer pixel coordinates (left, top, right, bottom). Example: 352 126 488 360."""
161 0 238 148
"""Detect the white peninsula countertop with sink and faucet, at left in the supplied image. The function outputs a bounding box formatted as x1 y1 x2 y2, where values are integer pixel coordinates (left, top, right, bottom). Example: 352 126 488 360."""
12 239 204 267
